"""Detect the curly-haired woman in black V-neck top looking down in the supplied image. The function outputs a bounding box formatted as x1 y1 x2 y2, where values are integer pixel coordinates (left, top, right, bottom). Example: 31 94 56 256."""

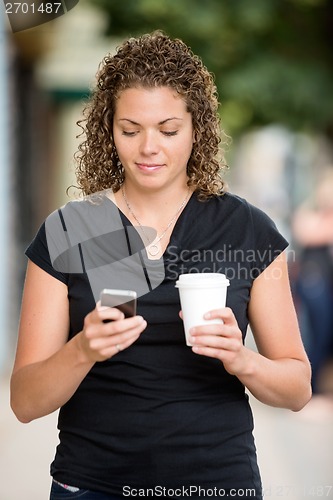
11 32 311 500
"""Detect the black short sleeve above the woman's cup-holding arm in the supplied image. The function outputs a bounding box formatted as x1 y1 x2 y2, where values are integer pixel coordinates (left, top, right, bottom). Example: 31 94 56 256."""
248 204 289 278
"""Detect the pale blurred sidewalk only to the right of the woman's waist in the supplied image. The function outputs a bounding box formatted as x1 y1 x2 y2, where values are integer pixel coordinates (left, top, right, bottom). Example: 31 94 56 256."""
251 399 333 500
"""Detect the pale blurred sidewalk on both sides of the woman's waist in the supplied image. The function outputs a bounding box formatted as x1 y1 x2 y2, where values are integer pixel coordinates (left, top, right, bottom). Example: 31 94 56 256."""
0 379 333 500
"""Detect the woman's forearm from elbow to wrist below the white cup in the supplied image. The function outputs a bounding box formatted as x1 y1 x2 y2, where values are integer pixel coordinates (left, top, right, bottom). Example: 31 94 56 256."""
238 348 311 411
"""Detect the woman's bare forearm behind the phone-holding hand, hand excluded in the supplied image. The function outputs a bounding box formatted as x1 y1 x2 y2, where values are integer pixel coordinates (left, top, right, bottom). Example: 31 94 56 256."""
11 334 94 423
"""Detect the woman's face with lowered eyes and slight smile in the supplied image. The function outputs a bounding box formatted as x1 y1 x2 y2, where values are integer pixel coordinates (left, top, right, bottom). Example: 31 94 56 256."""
113 87 194 190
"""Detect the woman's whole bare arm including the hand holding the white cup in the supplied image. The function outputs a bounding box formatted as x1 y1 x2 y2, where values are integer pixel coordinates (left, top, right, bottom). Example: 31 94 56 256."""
185 254 311 411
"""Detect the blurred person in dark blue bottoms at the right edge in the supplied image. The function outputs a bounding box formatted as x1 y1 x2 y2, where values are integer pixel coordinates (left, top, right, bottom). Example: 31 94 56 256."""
293 169 333 411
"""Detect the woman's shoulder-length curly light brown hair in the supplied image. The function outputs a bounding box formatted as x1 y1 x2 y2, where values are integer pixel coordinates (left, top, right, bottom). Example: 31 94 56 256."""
75 31 225 200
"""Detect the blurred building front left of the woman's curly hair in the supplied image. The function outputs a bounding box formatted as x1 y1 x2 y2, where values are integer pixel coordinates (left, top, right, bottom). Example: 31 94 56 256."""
0 0 114 374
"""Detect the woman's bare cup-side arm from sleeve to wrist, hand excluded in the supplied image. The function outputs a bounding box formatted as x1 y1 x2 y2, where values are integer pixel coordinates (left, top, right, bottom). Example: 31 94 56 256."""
241 253 311 411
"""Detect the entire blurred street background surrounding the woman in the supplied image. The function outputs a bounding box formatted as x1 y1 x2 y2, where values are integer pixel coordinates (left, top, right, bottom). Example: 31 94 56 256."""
0 0 333 500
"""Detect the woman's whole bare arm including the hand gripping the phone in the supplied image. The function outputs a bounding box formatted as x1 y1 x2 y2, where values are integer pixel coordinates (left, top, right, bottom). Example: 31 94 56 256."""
11 262 146 422
